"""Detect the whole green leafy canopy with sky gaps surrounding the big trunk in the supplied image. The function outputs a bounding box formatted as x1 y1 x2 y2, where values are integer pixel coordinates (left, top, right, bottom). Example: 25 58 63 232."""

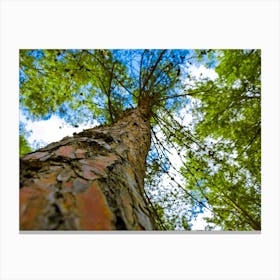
19 49 261 230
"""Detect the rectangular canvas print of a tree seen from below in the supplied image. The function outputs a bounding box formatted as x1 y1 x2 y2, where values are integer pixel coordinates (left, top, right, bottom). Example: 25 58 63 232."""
19 49 261 232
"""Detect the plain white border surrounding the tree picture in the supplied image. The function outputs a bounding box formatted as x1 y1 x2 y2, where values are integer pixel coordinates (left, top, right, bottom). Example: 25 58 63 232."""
0 0 280 280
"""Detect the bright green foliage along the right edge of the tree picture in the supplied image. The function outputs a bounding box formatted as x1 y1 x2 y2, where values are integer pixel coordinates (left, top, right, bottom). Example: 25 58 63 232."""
182 50 261 230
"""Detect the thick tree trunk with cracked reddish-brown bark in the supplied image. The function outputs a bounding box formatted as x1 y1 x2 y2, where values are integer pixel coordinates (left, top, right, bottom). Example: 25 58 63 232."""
20 108 156 230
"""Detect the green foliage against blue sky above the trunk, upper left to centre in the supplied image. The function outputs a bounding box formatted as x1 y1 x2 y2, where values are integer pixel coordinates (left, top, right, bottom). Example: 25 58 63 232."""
20 50 186 125
